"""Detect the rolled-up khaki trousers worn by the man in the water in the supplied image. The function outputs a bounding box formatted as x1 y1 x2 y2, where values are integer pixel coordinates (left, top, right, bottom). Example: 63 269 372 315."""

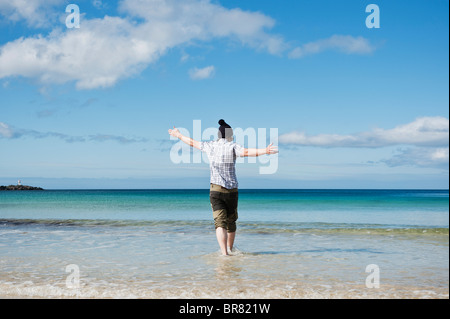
209 184 238 233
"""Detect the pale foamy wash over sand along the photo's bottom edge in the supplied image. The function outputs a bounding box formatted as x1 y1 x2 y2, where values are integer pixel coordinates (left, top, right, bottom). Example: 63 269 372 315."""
0 280 448 299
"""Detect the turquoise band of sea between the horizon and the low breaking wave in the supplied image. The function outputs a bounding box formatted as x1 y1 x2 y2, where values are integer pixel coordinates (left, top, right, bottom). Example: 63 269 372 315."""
0 190 448 228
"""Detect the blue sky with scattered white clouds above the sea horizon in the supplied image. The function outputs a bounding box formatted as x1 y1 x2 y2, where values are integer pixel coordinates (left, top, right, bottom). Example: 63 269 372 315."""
0 0 449 188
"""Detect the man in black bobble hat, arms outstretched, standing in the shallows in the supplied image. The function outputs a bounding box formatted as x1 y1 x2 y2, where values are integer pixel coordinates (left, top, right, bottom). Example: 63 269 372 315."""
169 120 278 255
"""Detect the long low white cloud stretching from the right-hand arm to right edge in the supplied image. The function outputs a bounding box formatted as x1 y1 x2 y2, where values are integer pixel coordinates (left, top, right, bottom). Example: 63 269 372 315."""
279 117 449 148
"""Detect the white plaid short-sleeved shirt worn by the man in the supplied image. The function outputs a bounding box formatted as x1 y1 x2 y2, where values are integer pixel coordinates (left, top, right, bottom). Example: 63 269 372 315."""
200 139 244 189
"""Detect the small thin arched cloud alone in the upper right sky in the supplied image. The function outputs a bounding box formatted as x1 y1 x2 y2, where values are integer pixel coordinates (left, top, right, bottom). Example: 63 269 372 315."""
289 35 375 59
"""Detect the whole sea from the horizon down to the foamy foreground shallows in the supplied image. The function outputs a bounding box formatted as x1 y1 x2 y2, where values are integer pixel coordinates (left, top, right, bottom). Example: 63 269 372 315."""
0 189 449 299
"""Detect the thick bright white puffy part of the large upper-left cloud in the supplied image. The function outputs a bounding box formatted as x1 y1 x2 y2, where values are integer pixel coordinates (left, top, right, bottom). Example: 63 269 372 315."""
0 17 158 89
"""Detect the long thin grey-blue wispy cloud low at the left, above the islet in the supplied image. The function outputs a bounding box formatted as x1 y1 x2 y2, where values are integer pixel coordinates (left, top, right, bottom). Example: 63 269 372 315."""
0 122 148 144
